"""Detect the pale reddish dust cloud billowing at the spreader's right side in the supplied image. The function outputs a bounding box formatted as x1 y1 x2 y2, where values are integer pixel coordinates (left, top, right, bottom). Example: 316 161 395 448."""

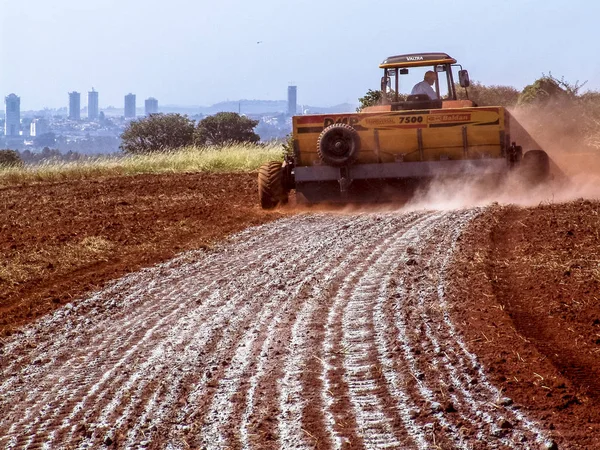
403 105 600 210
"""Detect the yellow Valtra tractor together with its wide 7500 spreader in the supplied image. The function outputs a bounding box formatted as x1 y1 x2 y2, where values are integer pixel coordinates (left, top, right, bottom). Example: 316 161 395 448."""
258 53 550 209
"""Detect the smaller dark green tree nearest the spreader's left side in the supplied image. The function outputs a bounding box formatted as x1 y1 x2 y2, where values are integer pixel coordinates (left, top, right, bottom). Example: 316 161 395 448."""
194 112 260 146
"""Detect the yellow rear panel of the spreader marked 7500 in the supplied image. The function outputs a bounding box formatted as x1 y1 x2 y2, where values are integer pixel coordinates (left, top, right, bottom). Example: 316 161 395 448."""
293 107 509 166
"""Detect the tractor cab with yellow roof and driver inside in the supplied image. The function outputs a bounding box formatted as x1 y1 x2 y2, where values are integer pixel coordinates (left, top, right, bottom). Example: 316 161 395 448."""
376 53 474 111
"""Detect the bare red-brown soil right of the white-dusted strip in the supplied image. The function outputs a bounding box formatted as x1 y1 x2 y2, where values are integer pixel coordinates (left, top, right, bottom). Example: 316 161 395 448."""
448 200 600 449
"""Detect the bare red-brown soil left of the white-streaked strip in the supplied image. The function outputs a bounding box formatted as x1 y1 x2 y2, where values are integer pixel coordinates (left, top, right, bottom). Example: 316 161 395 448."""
0 173 285 337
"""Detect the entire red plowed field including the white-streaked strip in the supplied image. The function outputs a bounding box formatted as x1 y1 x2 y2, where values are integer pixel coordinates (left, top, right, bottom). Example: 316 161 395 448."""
0 175 600 449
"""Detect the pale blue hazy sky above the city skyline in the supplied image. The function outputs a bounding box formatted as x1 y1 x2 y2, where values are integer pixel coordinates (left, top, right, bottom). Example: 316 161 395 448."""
0 0 600 111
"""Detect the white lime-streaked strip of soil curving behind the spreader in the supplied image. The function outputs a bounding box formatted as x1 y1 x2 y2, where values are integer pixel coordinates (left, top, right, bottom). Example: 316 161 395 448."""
0 209 551 449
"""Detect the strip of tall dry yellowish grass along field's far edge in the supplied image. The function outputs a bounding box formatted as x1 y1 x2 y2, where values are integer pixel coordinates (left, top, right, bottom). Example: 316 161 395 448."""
0 144 283 187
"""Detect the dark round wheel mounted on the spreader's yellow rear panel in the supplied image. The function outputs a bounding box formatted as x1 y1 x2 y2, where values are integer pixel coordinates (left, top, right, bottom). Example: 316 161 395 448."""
317 123 360 167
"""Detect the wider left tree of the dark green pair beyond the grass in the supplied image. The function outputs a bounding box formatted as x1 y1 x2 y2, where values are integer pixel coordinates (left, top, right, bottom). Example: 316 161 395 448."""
120 114 194 153
